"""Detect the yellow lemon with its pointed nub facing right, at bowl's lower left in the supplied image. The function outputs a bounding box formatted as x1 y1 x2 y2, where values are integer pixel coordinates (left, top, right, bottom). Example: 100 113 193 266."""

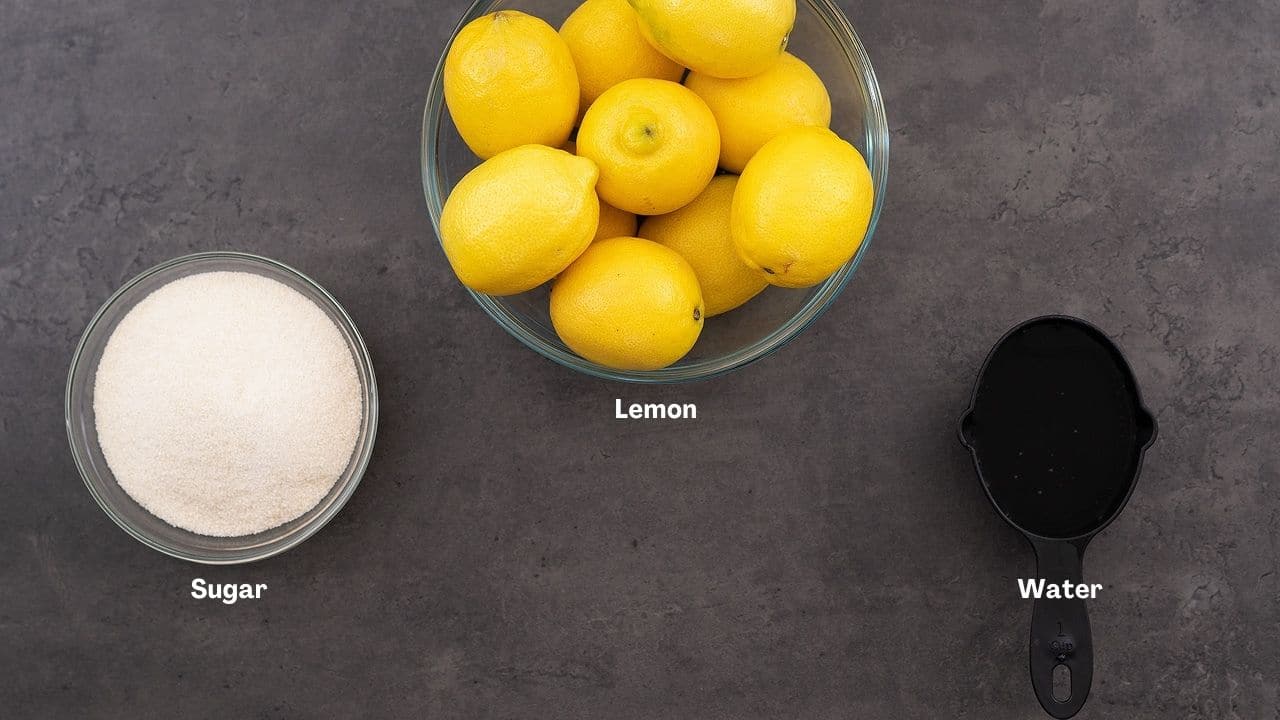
440 145 600 295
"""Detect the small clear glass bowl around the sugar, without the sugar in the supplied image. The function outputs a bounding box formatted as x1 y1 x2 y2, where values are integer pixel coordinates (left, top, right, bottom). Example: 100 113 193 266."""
65 252 378 565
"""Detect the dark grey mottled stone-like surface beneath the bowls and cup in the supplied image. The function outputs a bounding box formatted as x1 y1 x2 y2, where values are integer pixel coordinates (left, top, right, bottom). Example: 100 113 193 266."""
0 0 1280 720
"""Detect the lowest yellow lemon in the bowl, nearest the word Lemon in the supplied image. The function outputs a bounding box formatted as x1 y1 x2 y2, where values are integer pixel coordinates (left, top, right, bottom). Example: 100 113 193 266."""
552 237 704 370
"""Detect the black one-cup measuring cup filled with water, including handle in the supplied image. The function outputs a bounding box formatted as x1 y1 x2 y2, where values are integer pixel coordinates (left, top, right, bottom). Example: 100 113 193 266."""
960 315 1156 717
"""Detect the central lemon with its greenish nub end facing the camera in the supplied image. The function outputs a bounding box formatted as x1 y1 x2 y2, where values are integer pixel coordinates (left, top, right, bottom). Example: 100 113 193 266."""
577 78 719 215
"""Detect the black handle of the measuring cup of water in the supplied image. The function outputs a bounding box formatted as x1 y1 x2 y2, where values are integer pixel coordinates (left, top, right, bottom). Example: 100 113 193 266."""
1030 541 1093 719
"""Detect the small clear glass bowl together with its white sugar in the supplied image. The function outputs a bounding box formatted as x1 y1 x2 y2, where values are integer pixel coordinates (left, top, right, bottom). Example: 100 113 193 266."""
65 252 378 565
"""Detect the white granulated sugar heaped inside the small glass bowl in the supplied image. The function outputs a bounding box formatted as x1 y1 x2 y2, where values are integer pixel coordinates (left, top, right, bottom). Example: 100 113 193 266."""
93 272 362 537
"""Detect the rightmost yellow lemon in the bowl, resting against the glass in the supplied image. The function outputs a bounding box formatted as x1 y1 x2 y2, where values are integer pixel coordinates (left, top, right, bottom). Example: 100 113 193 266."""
730 127 876 287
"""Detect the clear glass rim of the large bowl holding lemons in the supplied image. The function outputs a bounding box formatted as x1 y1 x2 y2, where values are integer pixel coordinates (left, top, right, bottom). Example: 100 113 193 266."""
419 0 890 384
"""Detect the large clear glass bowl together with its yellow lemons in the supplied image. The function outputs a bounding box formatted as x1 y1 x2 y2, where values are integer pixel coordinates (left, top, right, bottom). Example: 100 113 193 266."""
421 0 888 383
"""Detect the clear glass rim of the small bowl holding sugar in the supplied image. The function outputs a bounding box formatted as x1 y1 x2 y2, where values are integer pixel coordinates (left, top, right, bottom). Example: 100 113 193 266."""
63 250 379 565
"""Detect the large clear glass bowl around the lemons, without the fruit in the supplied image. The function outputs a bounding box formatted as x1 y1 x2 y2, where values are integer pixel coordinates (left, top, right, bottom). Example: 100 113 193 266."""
421 0 888 383
